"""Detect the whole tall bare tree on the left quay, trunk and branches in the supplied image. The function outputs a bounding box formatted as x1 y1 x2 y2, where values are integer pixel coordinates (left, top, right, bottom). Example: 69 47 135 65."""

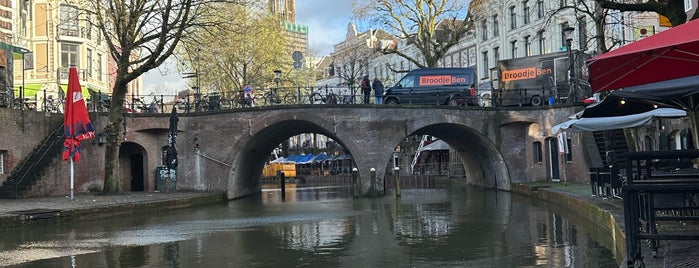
83 0 227 194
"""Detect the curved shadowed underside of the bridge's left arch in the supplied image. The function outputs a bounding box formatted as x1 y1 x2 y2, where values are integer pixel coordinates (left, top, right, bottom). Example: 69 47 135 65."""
228 119 354 198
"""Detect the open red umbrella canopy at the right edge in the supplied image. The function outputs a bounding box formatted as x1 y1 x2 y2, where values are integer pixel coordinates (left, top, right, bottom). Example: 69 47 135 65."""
587 20 699 93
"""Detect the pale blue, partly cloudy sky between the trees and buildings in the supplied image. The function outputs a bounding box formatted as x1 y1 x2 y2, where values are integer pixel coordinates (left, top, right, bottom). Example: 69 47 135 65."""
143 0 352 95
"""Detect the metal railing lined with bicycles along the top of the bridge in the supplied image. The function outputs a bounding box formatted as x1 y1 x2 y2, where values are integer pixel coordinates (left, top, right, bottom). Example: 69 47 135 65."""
0 86 576 113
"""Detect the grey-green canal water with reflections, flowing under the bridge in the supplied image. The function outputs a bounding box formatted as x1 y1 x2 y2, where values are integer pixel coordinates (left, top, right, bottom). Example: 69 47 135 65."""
0 185 619 267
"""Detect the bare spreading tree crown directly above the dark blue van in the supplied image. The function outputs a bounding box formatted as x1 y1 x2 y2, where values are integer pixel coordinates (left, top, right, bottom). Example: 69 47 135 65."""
354 0 472 68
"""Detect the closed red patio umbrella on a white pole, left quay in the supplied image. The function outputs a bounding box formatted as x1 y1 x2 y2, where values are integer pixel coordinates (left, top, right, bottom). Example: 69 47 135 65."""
63 66 95 200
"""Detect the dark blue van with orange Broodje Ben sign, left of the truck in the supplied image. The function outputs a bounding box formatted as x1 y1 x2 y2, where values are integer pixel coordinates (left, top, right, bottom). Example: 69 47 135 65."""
384 68 478 106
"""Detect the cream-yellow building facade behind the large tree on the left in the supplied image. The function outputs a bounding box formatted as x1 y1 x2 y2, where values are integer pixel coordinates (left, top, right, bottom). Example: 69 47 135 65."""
7 0 142 109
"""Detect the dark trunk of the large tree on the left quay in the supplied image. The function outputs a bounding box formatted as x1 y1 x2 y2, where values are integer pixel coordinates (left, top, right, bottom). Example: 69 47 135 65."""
102 76 127 194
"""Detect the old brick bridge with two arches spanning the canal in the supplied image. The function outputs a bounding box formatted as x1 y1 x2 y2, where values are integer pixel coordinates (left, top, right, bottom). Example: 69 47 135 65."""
120 105 580 199
